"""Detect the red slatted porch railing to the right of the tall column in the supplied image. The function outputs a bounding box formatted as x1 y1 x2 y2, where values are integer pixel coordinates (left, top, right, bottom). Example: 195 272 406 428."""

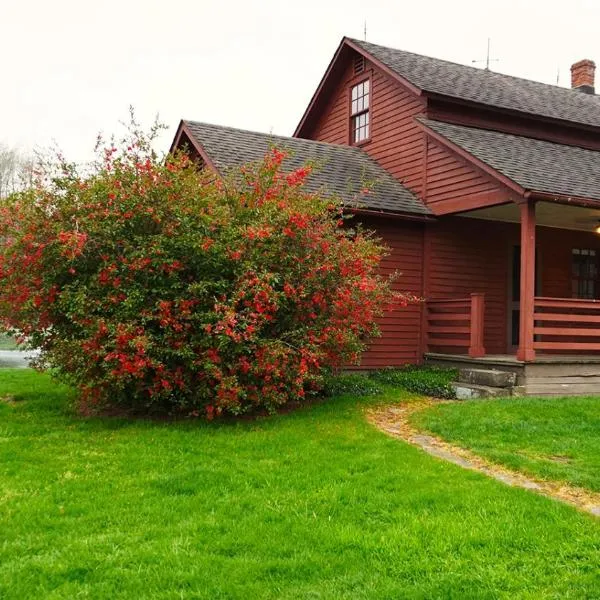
533 297 600 352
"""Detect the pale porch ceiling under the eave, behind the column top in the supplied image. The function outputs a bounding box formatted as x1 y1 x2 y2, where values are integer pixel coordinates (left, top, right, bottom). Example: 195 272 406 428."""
457 202 600 232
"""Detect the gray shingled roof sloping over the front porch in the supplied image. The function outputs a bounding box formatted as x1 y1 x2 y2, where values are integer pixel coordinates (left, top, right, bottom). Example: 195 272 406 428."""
419 118 600 200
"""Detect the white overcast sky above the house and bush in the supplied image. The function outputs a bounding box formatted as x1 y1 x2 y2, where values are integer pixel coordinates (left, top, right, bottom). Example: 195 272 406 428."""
0 0 600 160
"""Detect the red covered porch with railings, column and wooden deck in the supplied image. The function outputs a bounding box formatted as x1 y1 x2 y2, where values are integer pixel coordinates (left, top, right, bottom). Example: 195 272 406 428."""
423 200 600 395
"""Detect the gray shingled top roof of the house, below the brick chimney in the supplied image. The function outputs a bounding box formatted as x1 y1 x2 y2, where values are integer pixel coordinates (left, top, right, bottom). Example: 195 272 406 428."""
351 40 600 127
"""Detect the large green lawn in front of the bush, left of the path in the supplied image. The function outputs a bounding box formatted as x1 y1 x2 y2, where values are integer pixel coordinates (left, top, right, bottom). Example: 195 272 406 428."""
0 370 600 600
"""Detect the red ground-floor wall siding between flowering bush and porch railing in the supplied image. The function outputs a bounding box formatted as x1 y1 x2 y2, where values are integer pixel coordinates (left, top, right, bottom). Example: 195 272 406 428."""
360 219 423 369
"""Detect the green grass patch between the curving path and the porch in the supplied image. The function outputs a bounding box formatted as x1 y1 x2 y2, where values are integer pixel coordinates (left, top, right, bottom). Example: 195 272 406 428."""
412 397 600 492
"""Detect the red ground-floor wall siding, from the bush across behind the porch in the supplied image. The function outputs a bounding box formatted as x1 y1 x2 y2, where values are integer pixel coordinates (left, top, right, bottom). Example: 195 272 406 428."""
360 216 600 369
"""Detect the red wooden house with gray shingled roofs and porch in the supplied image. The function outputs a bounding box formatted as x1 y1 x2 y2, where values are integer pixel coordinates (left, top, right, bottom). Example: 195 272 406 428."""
173 38 600 393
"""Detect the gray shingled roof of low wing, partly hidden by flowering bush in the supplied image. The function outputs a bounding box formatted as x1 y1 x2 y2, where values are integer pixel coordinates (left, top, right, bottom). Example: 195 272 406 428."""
184 121 431 215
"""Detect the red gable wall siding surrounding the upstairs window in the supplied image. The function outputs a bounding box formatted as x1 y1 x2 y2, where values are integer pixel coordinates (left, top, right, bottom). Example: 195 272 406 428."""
307 55 424 194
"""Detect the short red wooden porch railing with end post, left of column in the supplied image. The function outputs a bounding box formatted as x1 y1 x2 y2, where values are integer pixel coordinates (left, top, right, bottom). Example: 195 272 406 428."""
426 294 485 358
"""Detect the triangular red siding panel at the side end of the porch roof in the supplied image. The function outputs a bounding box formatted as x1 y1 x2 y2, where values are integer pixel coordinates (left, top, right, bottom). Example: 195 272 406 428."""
424 139 509 214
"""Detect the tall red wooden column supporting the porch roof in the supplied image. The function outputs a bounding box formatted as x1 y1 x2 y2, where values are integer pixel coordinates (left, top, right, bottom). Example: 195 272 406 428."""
517 200 535 360
